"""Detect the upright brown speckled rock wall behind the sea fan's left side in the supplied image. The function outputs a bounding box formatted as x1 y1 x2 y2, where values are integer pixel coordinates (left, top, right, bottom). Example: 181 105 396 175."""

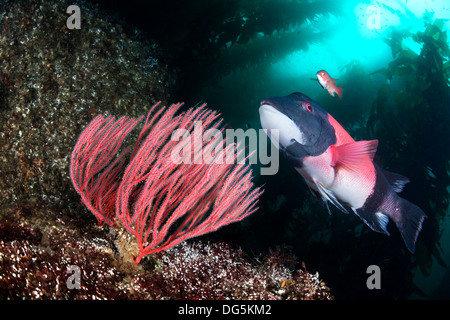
0 0 170 210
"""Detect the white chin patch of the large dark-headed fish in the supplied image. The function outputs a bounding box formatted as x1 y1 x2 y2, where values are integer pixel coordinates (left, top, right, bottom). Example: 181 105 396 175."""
259 104 304 148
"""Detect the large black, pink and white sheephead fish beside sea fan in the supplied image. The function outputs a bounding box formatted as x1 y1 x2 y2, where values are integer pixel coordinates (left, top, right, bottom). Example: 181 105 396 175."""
259 93 426 253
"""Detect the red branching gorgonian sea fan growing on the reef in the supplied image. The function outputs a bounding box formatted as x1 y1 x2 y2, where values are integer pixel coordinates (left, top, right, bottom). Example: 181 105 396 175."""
70 103 262 263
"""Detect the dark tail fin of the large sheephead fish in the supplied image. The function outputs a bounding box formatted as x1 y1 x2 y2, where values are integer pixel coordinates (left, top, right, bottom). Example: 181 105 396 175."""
392 198 427 253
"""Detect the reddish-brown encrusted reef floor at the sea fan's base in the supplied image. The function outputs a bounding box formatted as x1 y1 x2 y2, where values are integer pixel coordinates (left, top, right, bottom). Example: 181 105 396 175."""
0 207 332 300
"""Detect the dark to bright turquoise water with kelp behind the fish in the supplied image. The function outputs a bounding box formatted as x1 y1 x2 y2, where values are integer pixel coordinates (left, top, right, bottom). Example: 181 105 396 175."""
99 0 450 299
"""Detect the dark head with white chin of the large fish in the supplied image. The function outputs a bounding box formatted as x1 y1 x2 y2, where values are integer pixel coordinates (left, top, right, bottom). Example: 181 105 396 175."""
259 92 336 156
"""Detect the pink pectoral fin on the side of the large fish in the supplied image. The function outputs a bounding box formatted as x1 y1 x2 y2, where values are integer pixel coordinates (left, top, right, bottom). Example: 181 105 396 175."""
330 140 378 171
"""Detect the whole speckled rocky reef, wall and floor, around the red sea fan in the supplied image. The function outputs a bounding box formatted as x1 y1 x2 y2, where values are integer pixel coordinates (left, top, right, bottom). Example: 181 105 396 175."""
0 0 332 299
